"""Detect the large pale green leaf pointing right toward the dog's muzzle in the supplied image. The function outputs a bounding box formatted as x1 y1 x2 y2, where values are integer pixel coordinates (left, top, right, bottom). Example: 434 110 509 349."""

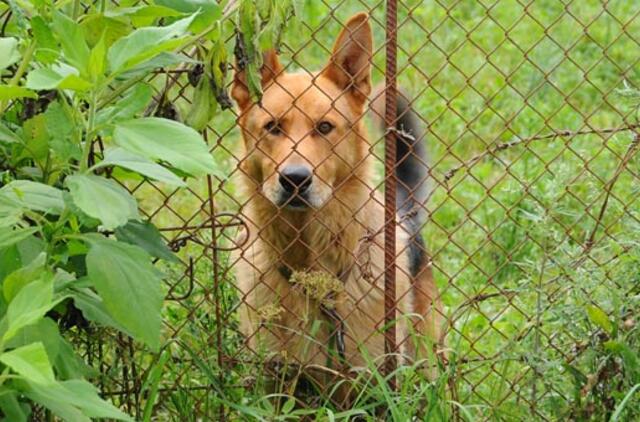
113 117 221 176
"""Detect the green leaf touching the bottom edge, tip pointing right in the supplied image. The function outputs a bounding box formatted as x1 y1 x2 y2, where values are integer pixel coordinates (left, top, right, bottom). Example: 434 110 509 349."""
25 380 133 422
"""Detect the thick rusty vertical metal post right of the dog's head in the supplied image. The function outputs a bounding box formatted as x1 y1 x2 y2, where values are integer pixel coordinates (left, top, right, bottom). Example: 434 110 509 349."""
384 0 398 389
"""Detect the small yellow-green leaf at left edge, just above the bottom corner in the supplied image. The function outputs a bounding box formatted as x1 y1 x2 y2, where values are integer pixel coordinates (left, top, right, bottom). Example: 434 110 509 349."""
0 342 55 385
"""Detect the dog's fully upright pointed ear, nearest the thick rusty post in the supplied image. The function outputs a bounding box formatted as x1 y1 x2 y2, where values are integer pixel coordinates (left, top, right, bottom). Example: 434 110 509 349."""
322 12 373 103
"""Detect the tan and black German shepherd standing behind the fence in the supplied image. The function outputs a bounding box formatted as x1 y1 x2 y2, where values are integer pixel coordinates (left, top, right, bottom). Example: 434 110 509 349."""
232 13 442 394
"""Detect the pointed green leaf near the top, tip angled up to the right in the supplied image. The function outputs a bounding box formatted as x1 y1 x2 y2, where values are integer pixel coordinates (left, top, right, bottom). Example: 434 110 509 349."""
107 15 195 73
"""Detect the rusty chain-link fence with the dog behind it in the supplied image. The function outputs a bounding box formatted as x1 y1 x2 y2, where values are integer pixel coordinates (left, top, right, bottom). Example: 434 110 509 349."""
7 0 640 420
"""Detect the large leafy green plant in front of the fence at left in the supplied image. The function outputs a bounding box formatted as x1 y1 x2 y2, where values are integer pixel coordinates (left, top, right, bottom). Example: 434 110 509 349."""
0 0 291 421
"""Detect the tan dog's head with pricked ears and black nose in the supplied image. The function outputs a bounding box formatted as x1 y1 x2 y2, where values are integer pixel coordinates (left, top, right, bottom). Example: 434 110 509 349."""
232 13 373 211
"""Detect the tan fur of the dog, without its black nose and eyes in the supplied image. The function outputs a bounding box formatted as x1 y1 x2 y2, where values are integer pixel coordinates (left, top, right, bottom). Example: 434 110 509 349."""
232 14 441 382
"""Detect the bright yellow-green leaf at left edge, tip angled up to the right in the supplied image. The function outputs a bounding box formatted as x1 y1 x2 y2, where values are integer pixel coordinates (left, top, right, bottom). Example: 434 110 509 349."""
2 276 56 341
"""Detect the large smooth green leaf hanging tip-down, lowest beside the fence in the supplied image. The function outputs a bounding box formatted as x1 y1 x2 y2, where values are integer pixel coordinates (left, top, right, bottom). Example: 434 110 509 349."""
85 235 163 350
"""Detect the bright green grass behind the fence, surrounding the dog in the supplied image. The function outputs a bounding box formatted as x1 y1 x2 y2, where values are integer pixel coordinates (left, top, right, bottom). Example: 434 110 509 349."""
86 0 640 421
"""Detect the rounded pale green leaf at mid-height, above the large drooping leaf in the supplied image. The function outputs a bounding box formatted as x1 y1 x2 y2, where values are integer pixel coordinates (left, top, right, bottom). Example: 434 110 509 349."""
65 174 139 230
